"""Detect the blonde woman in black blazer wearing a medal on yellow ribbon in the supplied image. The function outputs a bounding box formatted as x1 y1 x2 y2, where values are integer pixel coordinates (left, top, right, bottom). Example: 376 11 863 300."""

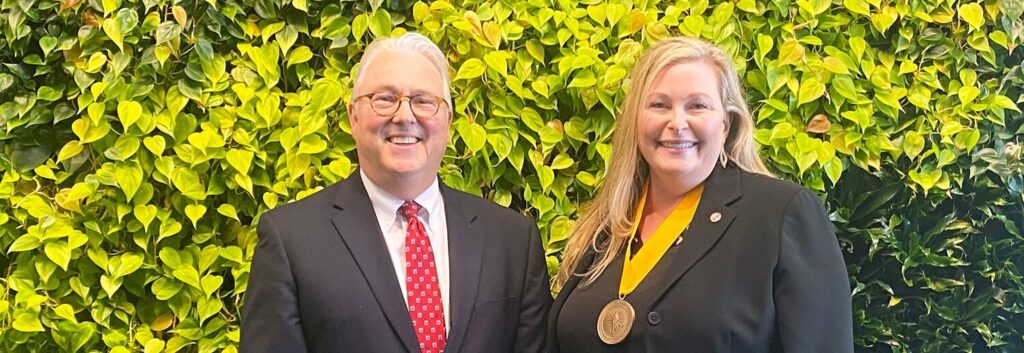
549 38 853 353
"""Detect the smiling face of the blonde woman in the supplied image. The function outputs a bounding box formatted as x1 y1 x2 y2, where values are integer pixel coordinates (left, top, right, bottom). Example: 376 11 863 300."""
637 61 729 185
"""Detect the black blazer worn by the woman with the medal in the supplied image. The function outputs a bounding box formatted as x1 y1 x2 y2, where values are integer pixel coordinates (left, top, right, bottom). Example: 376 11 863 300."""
548 167 853 353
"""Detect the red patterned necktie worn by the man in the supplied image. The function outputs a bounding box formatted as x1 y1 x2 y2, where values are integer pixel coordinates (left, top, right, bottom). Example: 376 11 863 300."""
398 201 447 353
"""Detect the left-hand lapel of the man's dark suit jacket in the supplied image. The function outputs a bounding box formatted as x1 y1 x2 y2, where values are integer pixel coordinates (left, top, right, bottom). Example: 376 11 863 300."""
331 174 420 352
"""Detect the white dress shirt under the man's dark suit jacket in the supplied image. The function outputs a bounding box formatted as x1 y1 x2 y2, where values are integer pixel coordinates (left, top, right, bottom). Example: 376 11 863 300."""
359 170 452 332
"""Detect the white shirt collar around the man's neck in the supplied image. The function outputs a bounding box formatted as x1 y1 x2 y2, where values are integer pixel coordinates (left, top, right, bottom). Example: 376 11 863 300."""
359 169 441 229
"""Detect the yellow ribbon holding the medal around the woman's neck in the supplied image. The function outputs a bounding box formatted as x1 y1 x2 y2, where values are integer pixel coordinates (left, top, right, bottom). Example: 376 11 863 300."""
618 183 703 299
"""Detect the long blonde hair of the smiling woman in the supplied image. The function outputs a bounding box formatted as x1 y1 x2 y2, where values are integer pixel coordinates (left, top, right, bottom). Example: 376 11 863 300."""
555 37 771 290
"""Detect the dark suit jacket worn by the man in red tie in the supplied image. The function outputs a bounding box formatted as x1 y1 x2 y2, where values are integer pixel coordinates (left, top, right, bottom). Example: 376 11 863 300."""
242 175 552 353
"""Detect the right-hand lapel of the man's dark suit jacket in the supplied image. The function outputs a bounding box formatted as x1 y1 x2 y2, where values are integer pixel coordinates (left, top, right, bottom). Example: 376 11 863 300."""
440 184 483 352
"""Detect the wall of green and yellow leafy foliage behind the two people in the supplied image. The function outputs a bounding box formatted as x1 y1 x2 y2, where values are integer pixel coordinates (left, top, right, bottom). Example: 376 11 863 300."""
0 0 1024 352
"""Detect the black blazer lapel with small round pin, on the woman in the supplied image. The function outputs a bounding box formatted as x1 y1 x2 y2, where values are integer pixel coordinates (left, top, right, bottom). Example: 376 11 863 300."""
651 166 741 301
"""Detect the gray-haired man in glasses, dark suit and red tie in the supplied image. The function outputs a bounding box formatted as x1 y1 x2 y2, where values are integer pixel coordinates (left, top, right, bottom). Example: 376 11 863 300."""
242 33 552 353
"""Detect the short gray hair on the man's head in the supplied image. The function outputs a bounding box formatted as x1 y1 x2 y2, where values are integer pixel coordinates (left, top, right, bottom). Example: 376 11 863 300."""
352 32 454 109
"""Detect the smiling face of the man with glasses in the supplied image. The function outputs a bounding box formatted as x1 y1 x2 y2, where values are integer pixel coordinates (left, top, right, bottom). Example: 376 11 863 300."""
348 52 452 188
